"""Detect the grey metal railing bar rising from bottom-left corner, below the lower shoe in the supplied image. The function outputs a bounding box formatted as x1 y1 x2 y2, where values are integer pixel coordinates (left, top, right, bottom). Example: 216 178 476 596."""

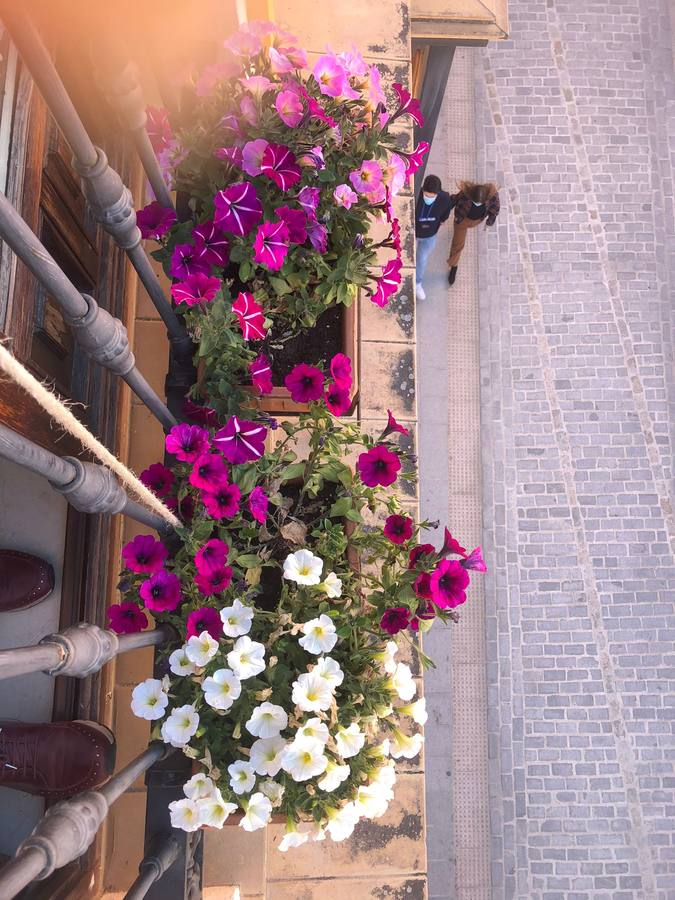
0 743 167 900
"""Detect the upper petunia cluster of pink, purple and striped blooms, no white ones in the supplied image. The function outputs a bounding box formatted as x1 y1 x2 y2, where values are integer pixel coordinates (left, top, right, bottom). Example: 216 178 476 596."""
138 22 428 413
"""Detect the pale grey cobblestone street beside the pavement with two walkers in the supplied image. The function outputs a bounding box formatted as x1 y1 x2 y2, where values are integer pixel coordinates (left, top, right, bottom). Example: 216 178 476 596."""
418 0 675 900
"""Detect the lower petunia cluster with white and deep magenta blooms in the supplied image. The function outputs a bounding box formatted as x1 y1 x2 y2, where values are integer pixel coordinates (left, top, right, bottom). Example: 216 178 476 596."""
110 370 484 850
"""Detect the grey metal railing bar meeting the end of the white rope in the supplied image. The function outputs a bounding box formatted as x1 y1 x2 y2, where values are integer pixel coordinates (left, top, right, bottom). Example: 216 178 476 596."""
0 424 176 534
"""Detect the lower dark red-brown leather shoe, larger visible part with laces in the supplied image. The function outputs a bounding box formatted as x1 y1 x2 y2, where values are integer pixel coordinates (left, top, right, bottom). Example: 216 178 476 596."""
0 721 116 800
